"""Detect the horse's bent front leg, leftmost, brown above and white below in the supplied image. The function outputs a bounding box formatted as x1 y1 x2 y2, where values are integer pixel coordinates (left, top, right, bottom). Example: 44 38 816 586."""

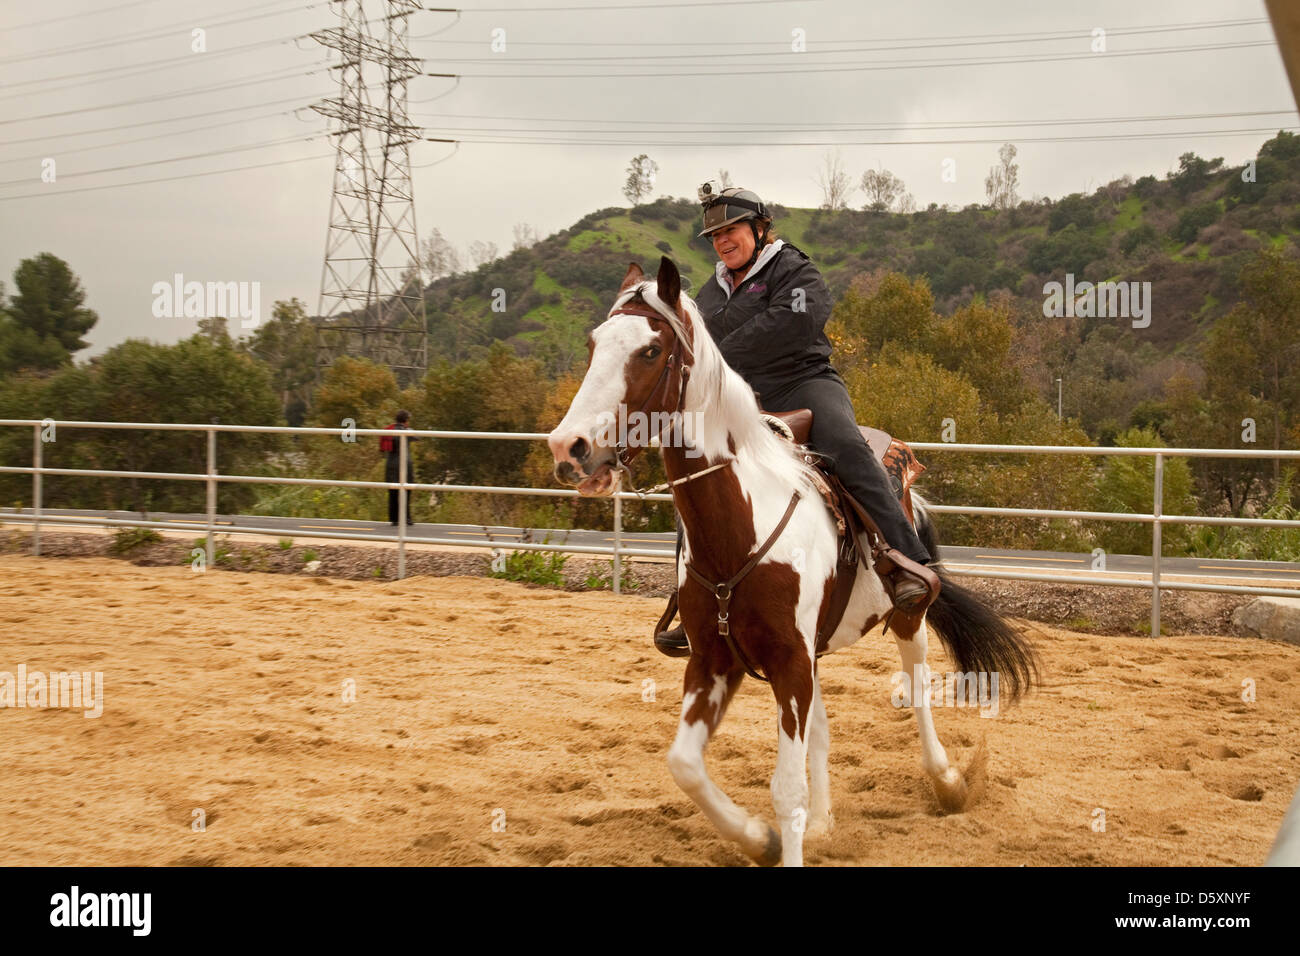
668 648 781 866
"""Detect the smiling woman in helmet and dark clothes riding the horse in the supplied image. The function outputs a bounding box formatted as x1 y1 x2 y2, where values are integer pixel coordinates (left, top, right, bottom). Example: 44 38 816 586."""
655 182 940 657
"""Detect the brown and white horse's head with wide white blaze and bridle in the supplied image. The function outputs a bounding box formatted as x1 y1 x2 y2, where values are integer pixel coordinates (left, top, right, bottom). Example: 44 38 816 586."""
547 256 693 497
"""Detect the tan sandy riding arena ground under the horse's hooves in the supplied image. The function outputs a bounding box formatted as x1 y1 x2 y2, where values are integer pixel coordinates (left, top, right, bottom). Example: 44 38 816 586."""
0 554 1300 866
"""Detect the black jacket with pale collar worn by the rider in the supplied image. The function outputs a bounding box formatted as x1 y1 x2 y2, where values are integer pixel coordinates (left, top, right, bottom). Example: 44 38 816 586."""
696 242 831 398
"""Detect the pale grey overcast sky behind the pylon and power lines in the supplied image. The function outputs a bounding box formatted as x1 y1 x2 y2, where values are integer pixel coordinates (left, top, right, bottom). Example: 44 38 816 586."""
0 0 1300 355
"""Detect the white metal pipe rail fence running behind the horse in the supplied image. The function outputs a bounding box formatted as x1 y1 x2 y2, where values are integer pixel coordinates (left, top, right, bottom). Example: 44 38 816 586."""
0 419 1300 637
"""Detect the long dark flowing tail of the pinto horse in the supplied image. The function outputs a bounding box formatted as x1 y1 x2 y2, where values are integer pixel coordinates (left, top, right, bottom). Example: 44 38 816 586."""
913 494 1039 701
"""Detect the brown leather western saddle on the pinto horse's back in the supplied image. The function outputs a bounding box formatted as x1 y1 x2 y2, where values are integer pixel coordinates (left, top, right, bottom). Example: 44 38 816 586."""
763 408 926 656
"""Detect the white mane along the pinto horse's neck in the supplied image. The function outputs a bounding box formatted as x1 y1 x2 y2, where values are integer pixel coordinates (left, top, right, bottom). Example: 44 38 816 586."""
610 280 816 497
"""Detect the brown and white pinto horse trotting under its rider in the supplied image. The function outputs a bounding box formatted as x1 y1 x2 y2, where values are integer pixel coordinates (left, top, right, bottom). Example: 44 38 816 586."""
549 258 1035 866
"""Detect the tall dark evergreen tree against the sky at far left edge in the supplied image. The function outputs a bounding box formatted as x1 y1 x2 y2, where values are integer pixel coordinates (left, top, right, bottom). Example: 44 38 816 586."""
0 252 99 373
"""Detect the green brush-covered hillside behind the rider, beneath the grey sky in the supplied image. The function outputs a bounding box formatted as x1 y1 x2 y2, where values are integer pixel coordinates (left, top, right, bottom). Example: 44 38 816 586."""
416 133 1300 440
